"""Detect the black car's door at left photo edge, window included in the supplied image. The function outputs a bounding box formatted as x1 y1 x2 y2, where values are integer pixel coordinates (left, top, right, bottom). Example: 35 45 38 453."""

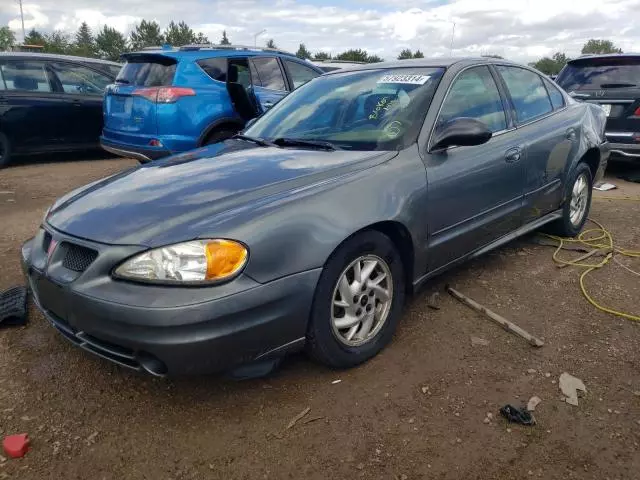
0 59 64 151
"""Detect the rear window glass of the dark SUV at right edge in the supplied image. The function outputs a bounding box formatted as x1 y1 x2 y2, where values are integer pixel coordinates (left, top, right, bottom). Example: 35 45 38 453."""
556 58 640 92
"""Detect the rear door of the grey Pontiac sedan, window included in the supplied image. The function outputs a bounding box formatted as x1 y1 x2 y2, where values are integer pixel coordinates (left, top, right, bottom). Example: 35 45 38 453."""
496 65 580 218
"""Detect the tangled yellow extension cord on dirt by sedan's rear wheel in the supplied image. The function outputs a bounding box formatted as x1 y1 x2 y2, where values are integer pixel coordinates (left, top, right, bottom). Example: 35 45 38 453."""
547 196 640 322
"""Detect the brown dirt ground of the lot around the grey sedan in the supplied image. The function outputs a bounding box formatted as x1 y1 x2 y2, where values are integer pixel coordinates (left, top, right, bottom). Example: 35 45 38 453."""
0 157 640 480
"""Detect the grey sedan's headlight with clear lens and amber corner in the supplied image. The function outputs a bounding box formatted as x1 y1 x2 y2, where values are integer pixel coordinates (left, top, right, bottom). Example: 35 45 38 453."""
114 239 249 283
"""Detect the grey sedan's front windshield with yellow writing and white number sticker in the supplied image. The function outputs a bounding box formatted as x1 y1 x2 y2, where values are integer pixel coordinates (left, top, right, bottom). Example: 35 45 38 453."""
245 67 444 150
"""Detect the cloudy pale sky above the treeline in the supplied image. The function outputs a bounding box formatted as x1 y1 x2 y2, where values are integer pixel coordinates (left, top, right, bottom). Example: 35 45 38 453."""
0 0 640 62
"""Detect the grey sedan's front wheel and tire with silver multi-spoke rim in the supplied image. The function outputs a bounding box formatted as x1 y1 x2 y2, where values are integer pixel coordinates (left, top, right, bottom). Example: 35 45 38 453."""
307 231 405 368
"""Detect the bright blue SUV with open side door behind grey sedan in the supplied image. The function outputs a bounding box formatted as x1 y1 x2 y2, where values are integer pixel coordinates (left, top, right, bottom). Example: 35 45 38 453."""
100 45 323 162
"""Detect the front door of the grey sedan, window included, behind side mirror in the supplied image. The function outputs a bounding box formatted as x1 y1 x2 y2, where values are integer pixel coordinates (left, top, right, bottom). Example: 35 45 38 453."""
426 66 526 271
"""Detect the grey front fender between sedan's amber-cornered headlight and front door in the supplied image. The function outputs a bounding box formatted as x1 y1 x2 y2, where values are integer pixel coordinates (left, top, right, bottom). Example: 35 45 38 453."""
223 146 427 283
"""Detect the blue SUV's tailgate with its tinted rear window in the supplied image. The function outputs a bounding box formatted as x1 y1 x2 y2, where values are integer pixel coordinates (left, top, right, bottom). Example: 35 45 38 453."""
104 54 177 135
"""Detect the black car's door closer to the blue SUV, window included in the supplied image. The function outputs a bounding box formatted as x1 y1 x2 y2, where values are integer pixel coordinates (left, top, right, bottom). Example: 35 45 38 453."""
48 62 113 144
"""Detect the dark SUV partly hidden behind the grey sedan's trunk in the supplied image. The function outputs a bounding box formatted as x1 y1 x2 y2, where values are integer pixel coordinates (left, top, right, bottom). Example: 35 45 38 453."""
556 54 640 163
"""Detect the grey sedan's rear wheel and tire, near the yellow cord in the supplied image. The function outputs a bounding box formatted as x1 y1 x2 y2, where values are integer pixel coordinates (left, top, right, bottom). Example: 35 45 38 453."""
548 162 593 237
